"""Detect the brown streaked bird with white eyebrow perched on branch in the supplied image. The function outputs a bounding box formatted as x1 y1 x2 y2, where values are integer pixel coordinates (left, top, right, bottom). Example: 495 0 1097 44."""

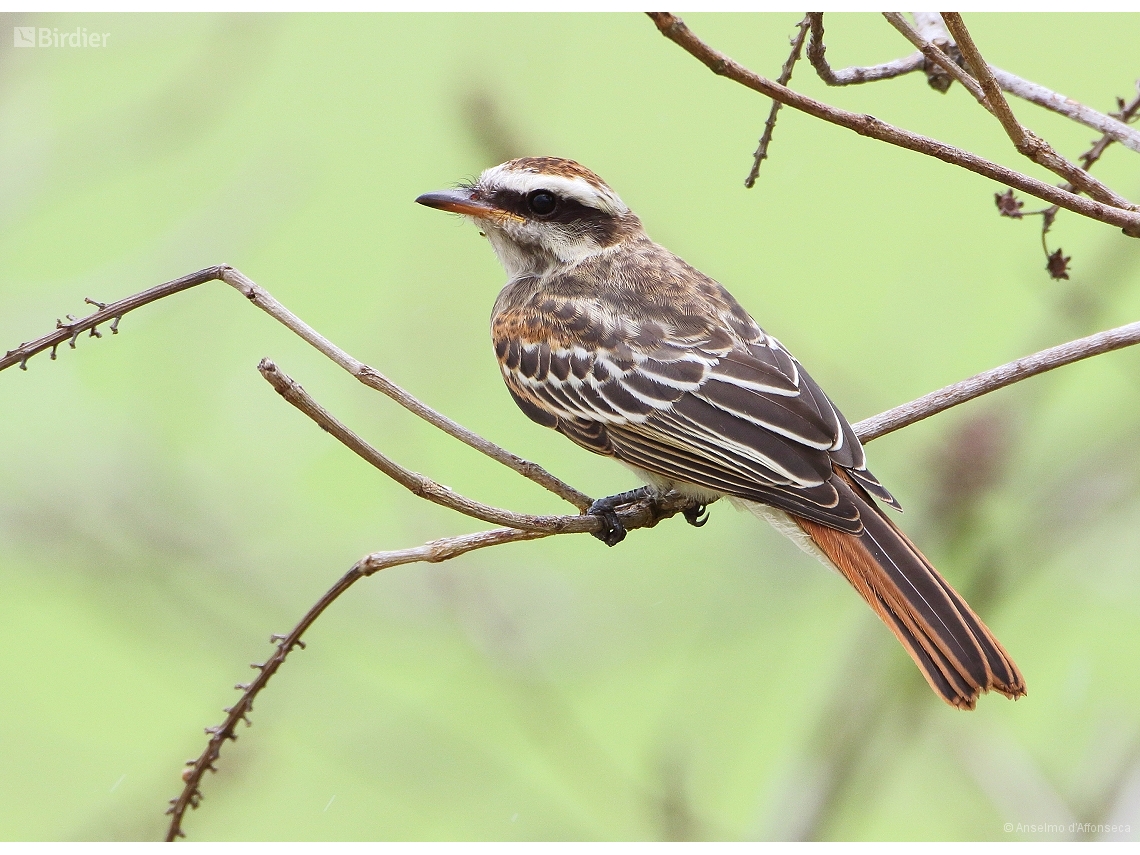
416 157 1025 709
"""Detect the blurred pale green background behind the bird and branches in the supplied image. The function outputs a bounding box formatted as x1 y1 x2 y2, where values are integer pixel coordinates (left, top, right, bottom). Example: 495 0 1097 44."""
0 14 1140 840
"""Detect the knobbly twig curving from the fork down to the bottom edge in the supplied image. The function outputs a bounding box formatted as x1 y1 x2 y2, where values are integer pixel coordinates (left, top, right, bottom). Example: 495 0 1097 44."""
166 529 549 841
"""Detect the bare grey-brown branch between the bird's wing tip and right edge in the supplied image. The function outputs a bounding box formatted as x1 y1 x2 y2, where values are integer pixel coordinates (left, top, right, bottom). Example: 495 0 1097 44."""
853 321 1140 442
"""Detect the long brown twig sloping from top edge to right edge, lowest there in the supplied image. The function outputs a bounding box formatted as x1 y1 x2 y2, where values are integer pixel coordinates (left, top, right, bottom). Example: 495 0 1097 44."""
649 13 1140 237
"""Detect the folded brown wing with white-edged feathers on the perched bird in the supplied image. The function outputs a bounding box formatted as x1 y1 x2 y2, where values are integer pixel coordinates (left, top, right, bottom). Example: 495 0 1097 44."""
494 300 897 532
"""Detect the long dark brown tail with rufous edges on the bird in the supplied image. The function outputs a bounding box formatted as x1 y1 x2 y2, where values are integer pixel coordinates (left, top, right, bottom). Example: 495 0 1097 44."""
791 470 1025 709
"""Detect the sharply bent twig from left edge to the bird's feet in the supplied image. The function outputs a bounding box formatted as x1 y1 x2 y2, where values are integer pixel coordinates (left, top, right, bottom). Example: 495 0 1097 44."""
0 264 591 511
